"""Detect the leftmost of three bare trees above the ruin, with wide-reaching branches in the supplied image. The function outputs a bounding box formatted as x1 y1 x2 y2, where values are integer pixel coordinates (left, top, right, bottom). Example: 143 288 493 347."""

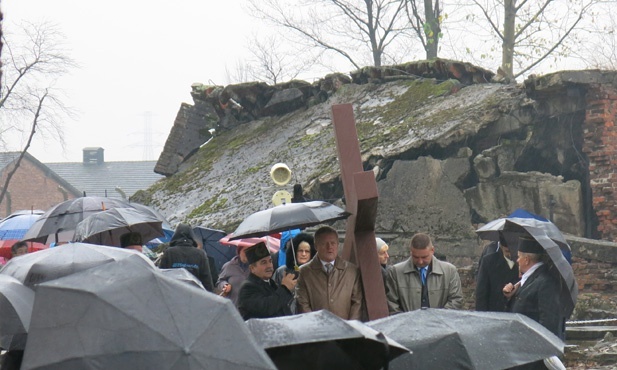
249 0 410 69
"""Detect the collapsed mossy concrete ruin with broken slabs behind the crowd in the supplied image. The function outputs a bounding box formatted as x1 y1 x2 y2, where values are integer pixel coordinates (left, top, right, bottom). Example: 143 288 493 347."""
142 60 617 315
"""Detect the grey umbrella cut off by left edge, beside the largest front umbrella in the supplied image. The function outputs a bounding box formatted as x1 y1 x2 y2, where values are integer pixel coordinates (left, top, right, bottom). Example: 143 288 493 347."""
0 274 34 350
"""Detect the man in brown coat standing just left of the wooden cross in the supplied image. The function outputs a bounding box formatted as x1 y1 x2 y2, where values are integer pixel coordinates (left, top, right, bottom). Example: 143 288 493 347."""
297 226 362 320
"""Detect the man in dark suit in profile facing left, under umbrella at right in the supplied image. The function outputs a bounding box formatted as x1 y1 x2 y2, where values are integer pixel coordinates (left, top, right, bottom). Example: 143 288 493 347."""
503 238 564 370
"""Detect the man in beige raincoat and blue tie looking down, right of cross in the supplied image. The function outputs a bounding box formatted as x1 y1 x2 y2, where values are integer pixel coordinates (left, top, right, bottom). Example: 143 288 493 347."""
386 233 463 313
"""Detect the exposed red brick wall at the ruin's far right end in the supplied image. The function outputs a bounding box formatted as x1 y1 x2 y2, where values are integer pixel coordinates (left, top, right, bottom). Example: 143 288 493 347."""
583 85 617 241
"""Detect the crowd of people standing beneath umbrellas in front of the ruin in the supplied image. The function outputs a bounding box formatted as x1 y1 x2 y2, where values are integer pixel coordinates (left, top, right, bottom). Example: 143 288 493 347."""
0 218 567 369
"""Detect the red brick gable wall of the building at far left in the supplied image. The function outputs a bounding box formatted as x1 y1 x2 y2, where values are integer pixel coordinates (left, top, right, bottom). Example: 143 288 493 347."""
0 159 74 217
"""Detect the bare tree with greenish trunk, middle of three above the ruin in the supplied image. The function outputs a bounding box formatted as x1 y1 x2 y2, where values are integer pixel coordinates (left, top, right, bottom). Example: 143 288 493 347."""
405 0 442 59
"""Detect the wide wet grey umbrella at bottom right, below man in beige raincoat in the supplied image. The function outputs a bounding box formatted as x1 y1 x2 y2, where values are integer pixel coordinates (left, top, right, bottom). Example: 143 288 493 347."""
367 308 564 370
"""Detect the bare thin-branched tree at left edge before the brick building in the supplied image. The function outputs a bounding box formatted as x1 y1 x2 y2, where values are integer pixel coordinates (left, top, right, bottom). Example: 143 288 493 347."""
0 23 75 203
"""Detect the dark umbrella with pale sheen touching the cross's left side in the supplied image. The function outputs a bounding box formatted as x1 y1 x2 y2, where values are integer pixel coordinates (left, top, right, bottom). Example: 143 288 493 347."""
230 201 351 240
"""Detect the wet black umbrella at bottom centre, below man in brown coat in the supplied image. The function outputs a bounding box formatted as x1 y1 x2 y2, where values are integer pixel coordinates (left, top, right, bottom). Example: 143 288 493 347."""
246 310 409 370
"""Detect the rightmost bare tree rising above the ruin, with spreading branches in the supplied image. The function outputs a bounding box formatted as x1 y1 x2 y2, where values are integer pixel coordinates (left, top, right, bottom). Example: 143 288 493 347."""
468 0 612 78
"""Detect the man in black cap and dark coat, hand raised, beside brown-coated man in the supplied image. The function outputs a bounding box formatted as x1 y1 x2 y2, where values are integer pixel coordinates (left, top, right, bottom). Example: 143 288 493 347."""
238 242 297 320
